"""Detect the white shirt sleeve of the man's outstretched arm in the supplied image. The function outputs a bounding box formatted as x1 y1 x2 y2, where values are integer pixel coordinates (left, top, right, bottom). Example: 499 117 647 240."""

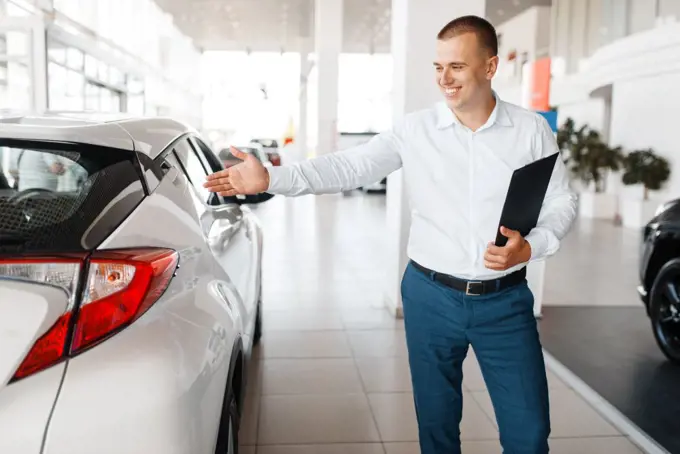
267 129 403 196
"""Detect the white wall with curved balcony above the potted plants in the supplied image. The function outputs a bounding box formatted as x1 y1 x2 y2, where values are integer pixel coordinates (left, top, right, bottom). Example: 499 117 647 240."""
551 20 680 206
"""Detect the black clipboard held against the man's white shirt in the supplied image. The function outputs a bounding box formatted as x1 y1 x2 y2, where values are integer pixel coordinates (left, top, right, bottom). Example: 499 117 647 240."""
495 152 560 247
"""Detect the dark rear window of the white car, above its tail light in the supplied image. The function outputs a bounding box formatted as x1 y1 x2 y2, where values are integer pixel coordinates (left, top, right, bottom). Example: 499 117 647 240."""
0 138 144 254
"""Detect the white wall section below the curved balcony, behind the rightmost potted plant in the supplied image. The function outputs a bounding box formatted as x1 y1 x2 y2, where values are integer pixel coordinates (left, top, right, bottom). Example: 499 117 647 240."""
611 72 680 200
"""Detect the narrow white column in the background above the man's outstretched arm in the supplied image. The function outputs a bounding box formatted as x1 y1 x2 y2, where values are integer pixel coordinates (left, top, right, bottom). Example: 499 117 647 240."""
314 0 343 155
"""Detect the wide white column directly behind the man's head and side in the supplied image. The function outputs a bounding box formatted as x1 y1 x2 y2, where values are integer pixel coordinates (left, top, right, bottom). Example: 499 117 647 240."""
385 0 486 317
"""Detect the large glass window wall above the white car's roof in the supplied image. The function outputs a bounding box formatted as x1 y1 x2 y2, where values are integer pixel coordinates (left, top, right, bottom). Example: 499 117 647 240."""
0 0 202 128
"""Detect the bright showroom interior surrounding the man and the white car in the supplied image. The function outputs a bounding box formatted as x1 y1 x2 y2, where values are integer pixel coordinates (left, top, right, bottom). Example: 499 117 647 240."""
0 0 680 454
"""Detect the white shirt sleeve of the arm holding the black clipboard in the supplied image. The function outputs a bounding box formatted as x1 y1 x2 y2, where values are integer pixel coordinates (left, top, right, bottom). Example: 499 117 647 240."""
526 117 576 261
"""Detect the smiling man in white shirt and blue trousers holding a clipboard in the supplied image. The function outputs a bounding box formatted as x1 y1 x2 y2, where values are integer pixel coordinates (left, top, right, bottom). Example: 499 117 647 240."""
205 16 576 454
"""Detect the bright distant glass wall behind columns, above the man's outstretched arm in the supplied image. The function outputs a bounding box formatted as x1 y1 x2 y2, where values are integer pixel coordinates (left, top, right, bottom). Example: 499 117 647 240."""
201 52 392 149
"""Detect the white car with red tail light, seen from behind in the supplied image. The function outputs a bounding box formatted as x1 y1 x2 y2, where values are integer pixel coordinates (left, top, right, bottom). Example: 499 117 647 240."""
0 117 267 454
